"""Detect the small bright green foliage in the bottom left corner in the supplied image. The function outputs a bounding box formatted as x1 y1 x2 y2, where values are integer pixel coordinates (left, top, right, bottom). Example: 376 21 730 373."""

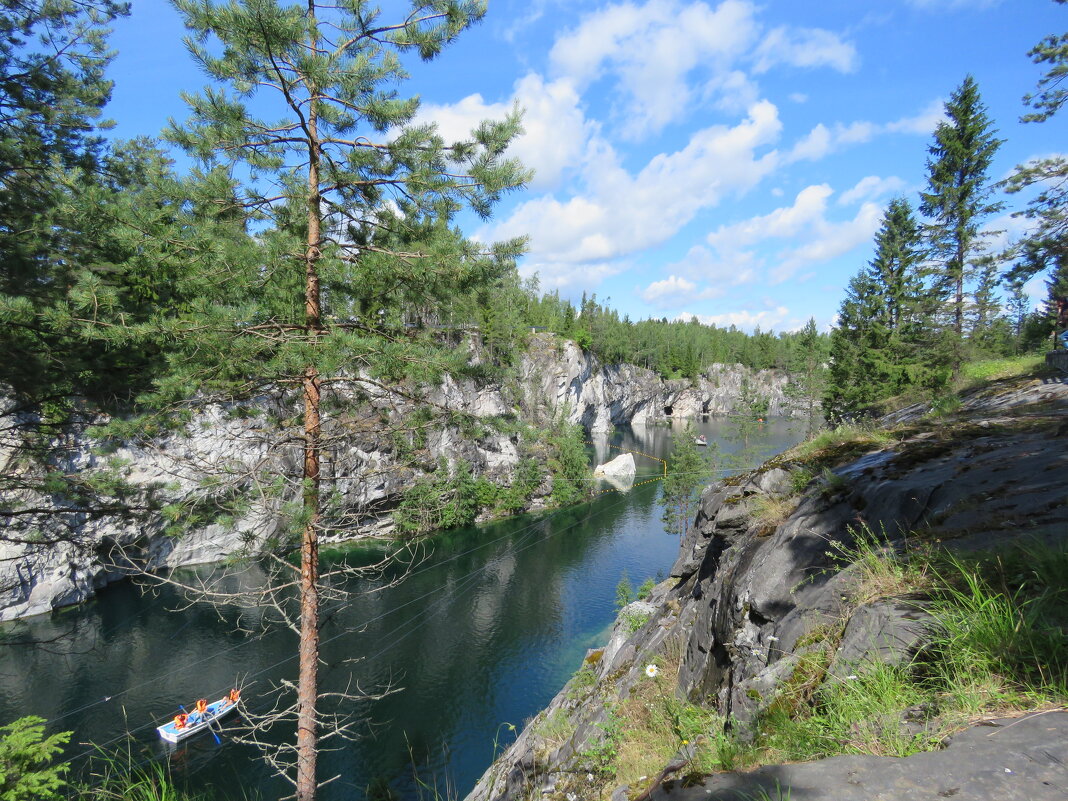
0 716 70 801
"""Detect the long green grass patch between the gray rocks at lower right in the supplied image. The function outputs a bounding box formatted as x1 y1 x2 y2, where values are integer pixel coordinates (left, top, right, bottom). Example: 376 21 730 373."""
750 536 1068 764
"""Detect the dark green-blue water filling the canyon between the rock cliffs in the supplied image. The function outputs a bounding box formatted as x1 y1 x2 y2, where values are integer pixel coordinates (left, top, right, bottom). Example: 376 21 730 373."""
0 420 802 801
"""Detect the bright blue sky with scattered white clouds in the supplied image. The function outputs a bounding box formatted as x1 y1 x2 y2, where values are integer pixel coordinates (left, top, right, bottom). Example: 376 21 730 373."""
101 0 1068 331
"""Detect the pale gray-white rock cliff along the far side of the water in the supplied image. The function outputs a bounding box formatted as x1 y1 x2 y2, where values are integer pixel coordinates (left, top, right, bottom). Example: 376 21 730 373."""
0 334 803 621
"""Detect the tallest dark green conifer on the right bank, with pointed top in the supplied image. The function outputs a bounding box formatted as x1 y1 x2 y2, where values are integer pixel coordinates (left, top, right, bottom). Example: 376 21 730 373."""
921 76 1004 375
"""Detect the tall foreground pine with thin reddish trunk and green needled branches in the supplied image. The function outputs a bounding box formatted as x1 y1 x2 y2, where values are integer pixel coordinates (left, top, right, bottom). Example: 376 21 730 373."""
130 0 525 801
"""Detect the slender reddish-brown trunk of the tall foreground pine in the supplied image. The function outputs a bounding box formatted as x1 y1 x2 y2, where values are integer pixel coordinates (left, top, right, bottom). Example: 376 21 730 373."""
296 12 323 801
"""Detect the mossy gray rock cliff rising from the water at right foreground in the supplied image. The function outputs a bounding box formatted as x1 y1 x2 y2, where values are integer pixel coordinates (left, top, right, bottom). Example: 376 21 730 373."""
468 378 1068 801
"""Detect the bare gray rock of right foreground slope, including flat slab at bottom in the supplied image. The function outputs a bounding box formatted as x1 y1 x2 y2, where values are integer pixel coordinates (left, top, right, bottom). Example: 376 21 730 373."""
468 381 1068 801
